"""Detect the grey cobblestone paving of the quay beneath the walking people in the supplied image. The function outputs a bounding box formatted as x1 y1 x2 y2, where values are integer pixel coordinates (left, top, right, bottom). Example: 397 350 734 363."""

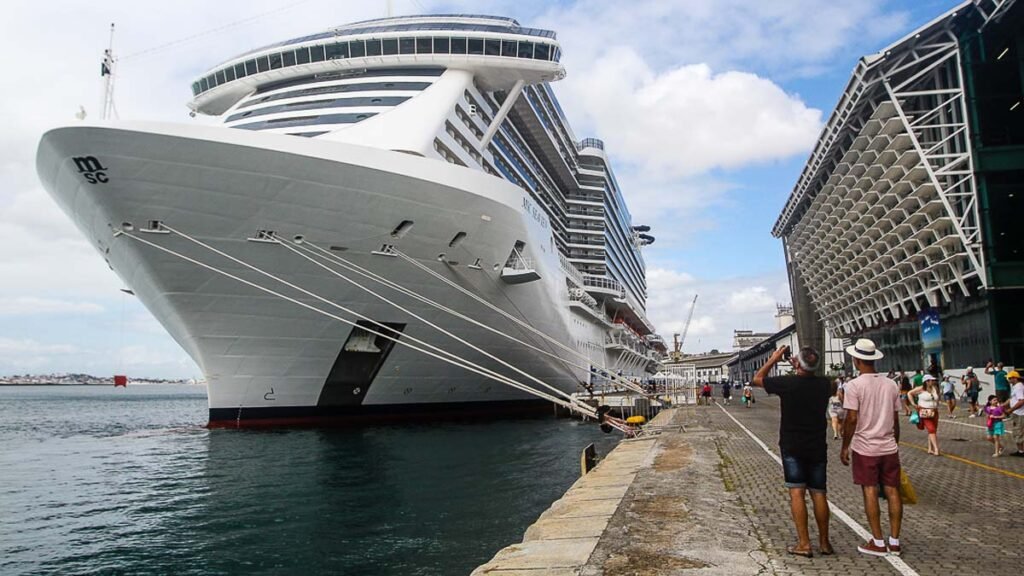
696 390 1024 576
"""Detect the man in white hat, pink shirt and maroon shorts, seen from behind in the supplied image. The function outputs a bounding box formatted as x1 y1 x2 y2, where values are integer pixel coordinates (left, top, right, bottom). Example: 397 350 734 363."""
840 338 903 556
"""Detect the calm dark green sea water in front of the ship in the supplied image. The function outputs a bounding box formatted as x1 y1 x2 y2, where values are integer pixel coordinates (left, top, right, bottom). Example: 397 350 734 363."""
0 386 615 575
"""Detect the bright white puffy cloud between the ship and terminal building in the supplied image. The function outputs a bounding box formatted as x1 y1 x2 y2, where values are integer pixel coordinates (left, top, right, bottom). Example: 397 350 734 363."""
563 53 821 177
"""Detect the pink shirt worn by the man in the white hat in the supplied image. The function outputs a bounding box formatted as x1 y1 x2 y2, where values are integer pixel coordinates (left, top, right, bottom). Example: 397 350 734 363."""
843 374 901 456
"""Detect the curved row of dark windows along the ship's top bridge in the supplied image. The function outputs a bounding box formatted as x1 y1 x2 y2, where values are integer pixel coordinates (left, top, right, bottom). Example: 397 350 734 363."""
193 38 561 95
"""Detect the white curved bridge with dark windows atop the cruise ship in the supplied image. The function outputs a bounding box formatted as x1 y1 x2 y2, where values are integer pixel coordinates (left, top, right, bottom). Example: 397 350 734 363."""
188 14 565 115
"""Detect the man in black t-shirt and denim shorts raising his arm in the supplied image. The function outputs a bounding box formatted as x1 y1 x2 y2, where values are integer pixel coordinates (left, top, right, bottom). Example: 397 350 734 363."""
754 346 834 558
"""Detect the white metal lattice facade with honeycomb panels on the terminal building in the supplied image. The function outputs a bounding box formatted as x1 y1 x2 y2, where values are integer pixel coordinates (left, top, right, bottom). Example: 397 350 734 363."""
772 0 991 335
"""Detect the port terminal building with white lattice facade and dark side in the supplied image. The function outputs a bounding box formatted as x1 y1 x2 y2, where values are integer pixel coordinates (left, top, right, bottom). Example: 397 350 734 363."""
772 0 1024 370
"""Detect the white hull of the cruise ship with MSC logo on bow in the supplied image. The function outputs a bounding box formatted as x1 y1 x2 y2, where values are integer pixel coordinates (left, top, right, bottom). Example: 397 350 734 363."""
37 123 605 422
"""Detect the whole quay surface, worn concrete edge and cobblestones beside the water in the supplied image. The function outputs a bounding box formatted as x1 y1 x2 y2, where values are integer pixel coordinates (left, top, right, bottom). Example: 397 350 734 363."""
473 393 1024 576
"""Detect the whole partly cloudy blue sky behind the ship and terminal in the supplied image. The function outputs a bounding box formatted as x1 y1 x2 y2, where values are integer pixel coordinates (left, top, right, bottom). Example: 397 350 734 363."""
0 0 956 378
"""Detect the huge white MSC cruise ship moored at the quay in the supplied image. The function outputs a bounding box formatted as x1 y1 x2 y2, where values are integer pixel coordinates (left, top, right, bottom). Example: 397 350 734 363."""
37 14 665 425
